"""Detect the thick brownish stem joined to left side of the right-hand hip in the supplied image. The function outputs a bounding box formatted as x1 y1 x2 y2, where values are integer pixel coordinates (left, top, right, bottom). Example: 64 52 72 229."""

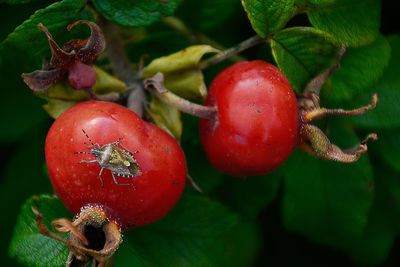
144 72 218 120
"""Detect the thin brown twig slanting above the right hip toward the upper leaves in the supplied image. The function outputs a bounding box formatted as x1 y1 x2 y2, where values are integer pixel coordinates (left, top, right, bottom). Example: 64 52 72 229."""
199 35 269 70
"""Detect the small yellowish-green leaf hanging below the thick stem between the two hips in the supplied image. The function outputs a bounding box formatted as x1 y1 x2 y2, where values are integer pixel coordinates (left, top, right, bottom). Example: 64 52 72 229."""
150 97 182 141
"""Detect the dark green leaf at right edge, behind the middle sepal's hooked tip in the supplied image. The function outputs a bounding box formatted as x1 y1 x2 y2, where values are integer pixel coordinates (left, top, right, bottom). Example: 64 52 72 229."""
351 35 400 130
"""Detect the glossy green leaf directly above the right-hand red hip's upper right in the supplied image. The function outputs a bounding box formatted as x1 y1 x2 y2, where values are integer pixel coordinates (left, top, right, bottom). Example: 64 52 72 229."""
271 27 340 93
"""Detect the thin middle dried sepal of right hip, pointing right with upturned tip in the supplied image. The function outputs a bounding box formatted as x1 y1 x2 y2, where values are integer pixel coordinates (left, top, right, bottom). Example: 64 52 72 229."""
303 93 378 123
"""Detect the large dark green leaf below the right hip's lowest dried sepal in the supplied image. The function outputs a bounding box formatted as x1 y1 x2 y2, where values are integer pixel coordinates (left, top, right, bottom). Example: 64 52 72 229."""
283 122 374 248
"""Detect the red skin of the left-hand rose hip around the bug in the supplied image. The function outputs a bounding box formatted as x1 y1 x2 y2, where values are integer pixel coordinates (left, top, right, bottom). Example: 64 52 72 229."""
45 101 186 230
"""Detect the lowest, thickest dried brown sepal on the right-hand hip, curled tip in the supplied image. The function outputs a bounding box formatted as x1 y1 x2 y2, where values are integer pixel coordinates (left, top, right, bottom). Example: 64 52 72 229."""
299 125 378 163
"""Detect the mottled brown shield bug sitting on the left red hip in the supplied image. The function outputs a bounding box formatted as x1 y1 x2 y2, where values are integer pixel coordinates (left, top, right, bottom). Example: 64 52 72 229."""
75 129 142 189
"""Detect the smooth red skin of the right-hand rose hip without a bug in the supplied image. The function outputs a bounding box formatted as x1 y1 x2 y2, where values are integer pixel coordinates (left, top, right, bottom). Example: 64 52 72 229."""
200 60 299 176
